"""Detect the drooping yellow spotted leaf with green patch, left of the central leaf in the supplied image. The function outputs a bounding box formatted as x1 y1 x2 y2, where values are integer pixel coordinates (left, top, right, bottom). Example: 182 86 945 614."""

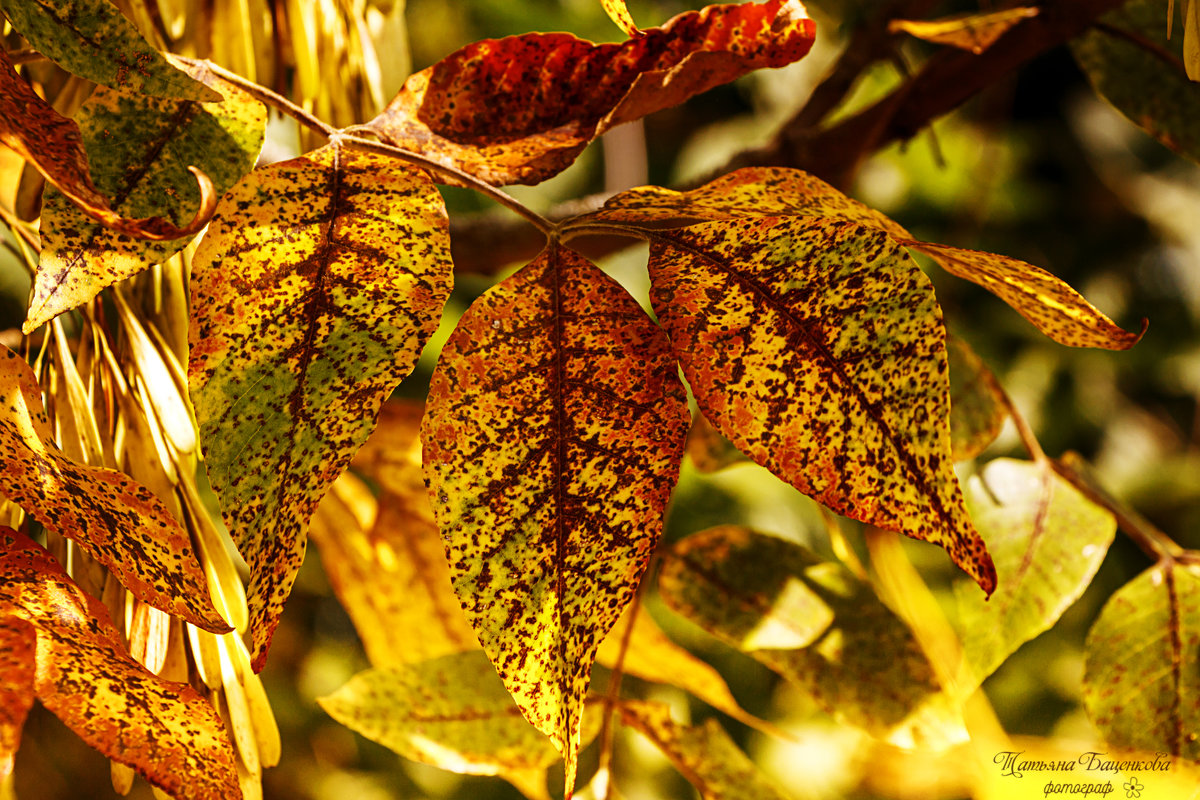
188 143 452 670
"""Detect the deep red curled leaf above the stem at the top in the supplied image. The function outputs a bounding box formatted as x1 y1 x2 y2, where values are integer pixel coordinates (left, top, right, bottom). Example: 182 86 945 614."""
371 0 815 185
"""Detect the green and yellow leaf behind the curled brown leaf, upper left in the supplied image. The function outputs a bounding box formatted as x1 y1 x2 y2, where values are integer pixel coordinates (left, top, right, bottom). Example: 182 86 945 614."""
24 65 266 332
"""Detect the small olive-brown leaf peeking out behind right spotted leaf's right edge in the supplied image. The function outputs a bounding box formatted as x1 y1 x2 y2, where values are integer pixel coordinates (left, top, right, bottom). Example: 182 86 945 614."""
946 336 1008 462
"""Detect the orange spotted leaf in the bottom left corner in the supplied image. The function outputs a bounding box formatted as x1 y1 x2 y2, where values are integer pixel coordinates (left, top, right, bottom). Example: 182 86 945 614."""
0 528 240 800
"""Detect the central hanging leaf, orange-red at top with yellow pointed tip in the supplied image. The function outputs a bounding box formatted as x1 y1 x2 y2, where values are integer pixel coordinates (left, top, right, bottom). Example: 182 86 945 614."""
421 246 689 794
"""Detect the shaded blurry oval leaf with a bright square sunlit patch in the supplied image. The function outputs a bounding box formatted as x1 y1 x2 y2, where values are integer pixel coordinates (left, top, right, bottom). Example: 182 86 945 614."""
659 527 940 735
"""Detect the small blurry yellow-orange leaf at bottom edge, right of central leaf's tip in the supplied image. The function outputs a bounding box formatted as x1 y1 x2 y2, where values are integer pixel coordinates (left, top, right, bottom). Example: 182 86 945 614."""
620 700 787 800
